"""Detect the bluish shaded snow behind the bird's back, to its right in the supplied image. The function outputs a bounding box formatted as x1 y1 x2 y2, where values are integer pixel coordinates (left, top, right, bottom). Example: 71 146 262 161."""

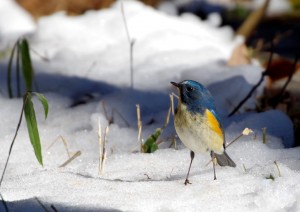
208 76 294 148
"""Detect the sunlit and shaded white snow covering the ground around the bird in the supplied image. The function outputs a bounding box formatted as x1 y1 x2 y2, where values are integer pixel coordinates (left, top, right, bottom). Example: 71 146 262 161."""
0 0 300 211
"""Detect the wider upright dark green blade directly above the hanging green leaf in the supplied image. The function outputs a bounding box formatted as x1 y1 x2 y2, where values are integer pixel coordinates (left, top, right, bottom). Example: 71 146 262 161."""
20 39 33 91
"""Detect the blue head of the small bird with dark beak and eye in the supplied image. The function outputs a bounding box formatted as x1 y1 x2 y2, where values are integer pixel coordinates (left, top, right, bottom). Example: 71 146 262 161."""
171 80 215 110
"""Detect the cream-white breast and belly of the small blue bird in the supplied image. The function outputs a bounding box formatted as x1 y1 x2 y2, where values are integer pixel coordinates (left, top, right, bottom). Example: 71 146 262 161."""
174 107 224 154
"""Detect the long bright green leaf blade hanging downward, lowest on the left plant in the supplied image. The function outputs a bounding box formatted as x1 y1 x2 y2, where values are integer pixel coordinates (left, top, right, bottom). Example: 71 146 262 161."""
23 93 43 165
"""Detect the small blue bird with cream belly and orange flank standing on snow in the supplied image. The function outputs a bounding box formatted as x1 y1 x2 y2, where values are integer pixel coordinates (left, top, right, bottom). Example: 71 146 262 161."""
170 80 236 185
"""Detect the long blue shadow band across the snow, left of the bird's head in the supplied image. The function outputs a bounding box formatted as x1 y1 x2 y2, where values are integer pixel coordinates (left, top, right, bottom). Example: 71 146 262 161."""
0 63 171 127
